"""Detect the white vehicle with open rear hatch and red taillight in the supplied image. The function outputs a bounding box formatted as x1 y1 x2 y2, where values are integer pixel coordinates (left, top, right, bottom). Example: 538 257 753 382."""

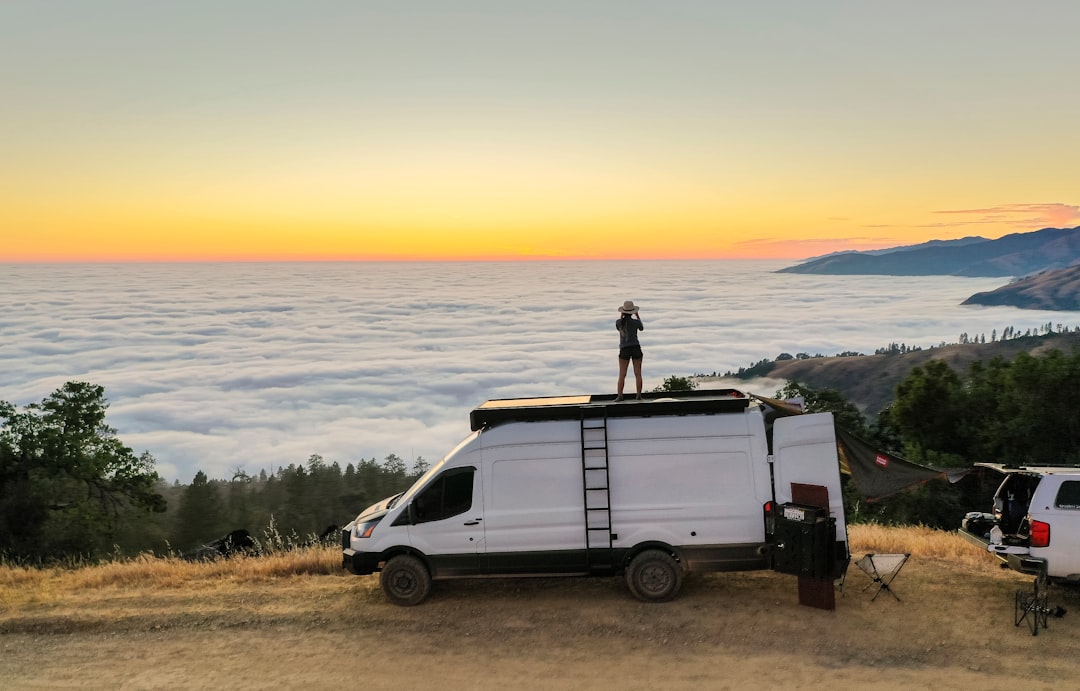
960 463 1080 582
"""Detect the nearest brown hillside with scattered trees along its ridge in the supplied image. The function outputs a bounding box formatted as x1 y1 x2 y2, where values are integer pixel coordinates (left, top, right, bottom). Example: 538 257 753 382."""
721 331 1080 417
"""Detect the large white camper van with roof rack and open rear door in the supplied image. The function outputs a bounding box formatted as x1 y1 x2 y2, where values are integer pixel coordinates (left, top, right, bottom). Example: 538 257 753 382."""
342 389 848 606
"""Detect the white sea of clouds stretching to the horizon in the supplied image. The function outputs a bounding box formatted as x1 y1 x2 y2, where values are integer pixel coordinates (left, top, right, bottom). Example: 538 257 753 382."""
0 261 1080 483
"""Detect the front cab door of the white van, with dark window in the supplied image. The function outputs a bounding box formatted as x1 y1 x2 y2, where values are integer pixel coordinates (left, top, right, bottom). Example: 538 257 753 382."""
402 465 484 578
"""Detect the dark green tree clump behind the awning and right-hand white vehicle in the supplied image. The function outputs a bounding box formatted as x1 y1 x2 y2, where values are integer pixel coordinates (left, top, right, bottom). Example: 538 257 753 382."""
873 351 1080 528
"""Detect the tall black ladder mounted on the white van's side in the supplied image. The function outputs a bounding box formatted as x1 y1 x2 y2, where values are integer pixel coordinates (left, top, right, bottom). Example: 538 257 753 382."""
581 409 615 572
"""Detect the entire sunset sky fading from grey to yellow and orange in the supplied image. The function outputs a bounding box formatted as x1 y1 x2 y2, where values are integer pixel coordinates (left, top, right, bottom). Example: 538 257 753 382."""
0 0 1080 262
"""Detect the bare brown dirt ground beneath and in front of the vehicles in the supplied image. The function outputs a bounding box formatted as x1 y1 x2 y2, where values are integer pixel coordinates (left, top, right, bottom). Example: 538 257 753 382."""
0 559 1080 690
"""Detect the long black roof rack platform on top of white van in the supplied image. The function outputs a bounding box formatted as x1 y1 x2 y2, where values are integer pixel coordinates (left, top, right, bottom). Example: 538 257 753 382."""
469 389 750 431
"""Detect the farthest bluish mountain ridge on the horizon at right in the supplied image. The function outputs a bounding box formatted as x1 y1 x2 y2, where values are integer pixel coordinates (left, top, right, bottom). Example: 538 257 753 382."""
778 226 1080 277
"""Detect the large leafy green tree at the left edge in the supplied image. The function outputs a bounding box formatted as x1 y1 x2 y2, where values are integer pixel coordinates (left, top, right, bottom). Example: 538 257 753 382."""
0 381 165 560
